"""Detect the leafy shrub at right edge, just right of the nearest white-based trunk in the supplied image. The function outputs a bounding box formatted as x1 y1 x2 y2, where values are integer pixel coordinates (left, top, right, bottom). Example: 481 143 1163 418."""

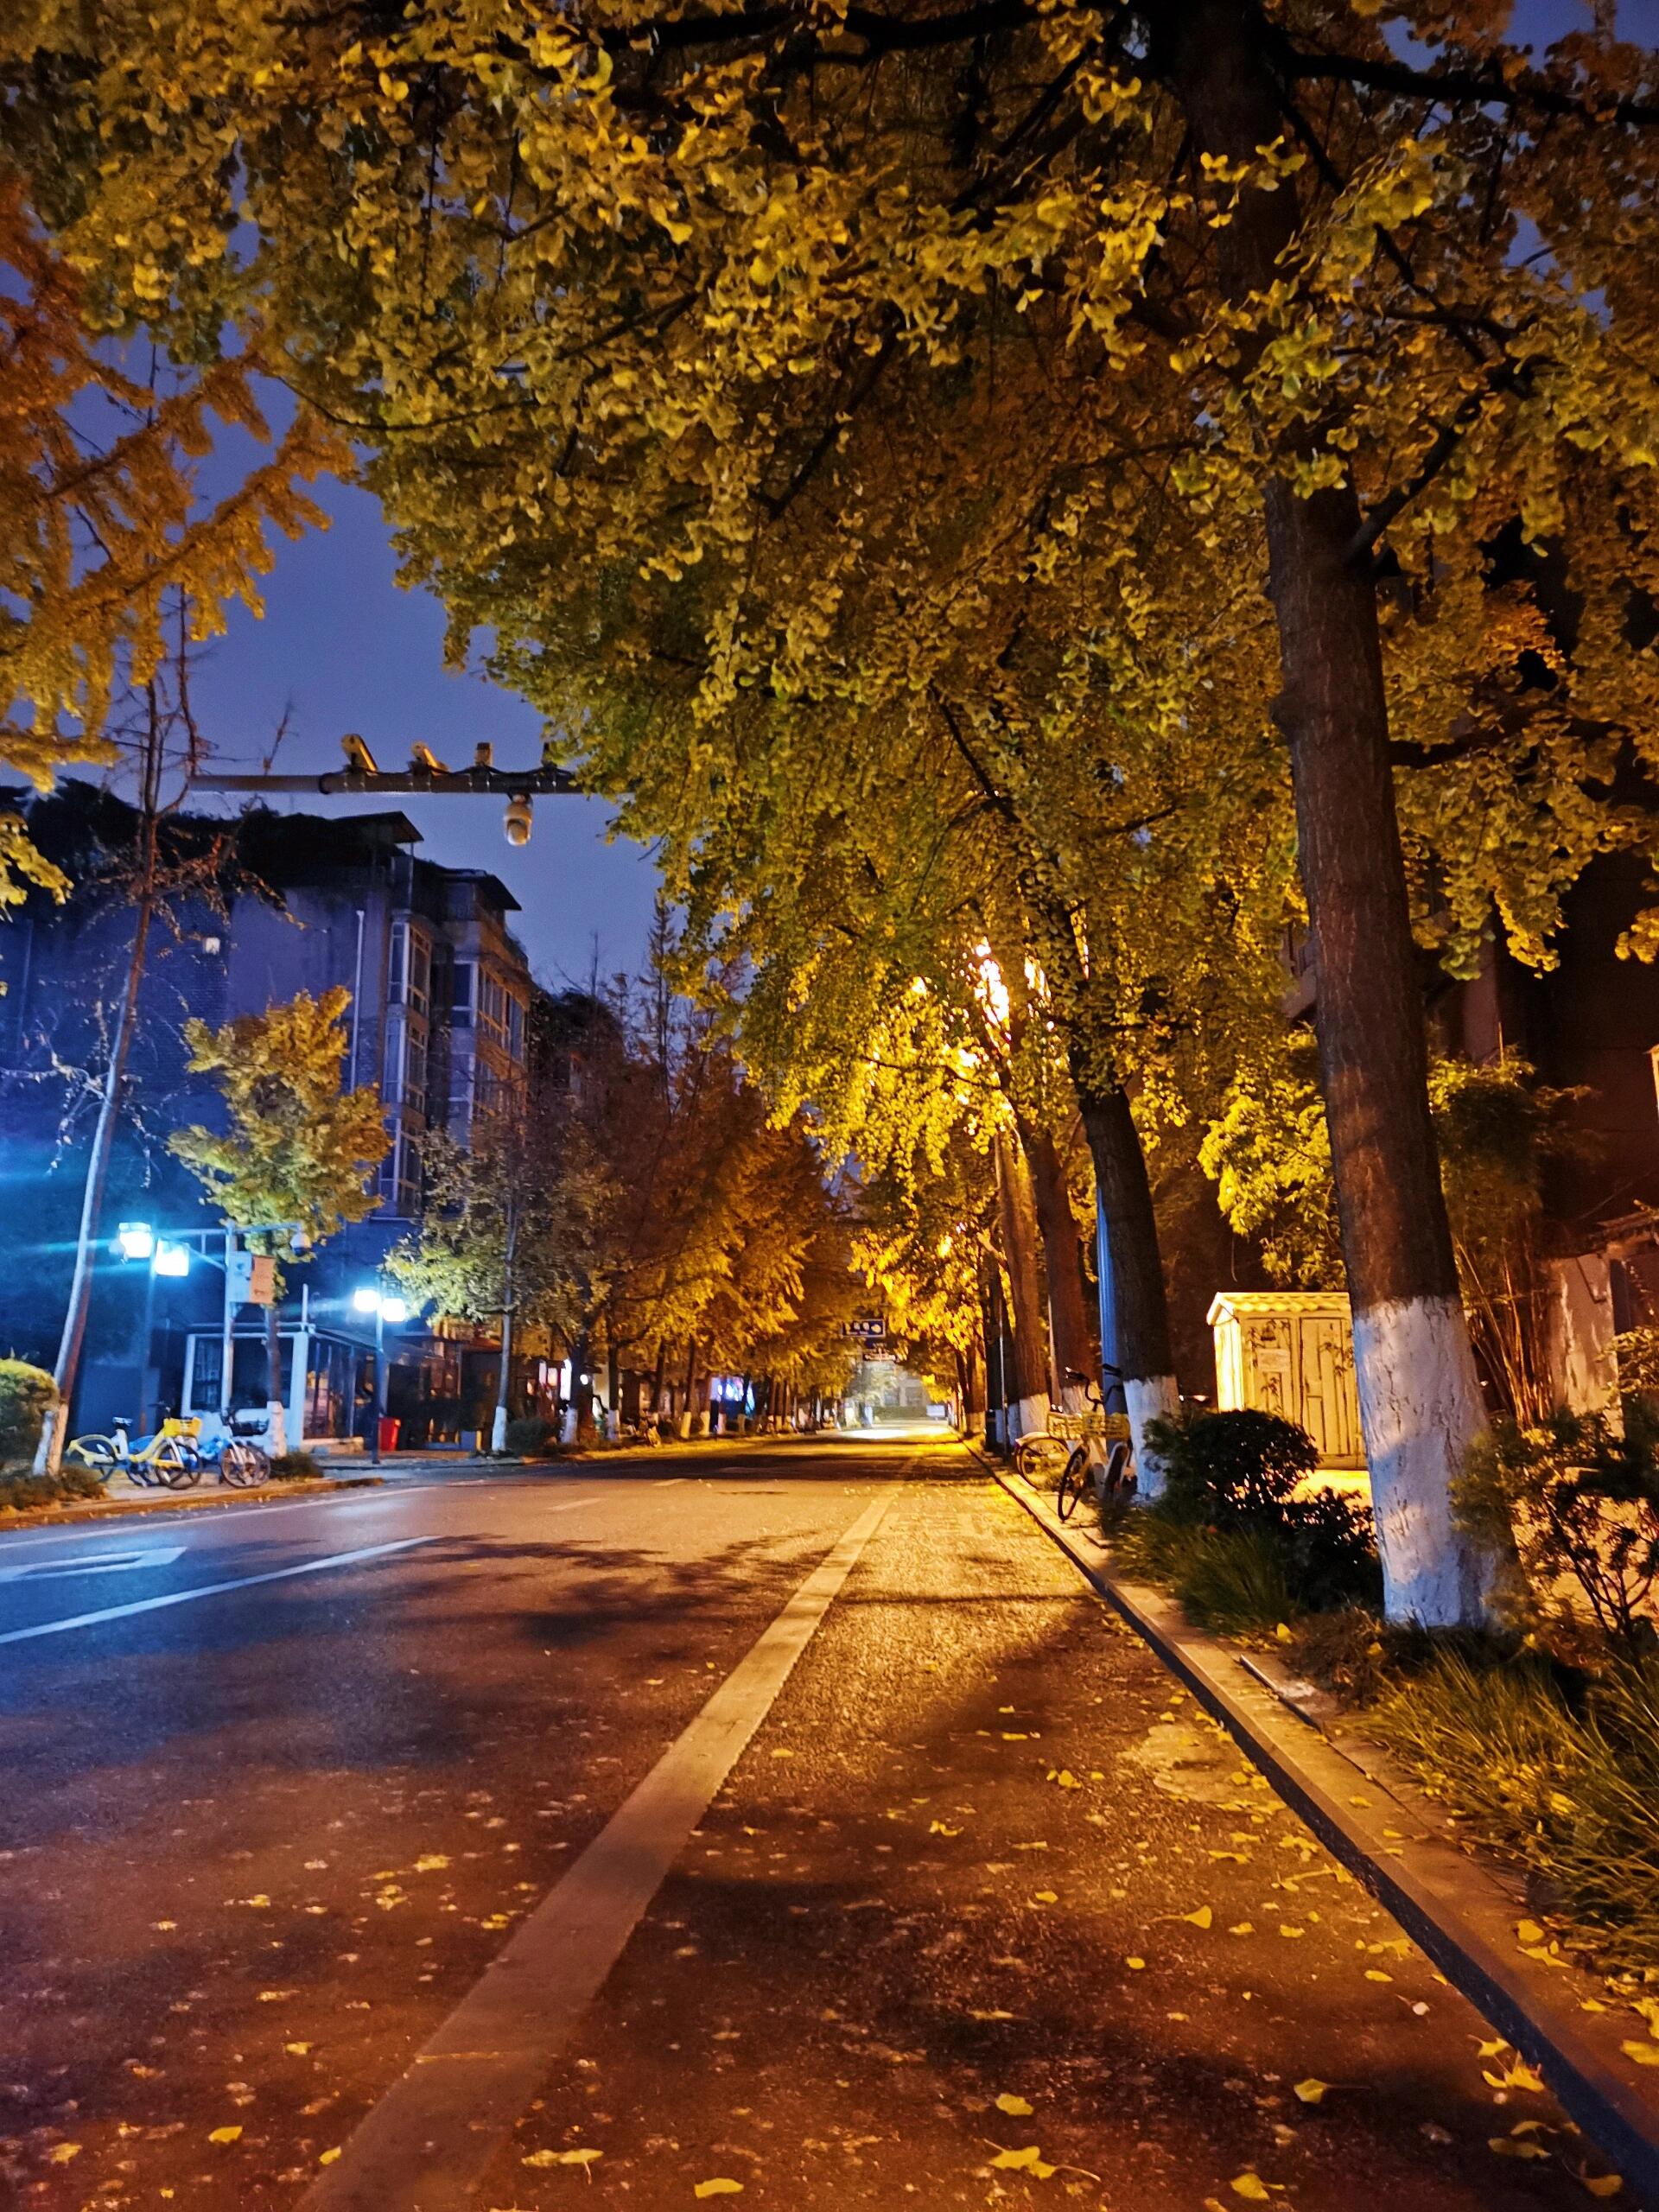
1455 1398 1659 1656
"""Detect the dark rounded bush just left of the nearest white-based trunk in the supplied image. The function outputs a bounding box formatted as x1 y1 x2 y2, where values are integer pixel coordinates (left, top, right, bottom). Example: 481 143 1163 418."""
1109 1409 1380 1632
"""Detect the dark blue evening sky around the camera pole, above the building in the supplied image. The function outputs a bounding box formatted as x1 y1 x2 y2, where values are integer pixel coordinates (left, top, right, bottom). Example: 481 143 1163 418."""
184 457 657 984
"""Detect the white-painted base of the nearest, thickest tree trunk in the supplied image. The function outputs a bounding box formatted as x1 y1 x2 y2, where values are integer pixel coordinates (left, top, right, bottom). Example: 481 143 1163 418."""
1354 1299 1491 1628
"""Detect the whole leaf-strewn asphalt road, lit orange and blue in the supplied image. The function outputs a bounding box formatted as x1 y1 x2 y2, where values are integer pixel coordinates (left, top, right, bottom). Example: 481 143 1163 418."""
0 1440 1628 2212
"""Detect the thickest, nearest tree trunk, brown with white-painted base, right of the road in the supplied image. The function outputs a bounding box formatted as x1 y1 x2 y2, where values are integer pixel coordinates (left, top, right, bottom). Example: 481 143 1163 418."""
1164 0 1484 1628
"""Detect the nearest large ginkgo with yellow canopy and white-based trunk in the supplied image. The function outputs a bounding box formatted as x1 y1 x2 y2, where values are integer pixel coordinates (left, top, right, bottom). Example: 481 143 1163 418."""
13 0 1659 1624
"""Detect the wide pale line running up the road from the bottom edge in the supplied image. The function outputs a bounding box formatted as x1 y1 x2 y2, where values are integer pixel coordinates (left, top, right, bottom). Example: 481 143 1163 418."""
299 1482 898 2212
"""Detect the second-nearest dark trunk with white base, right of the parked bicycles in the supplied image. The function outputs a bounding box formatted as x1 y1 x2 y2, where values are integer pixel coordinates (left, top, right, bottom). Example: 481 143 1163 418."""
1077 1077 1181 1500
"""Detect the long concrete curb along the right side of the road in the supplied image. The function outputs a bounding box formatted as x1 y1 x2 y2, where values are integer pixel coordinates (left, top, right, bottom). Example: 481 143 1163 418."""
982 1460 1659 2205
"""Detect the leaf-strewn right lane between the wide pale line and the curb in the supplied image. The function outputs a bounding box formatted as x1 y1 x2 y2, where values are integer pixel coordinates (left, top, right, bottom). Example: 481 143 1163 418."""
478 1480 1635 2212
